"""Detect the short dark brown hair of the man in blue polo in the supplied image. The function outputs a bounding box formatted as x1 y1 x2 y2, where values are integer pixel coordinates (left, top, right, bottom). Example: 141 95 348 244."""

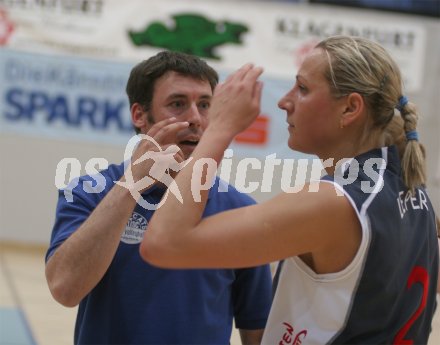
125 51 219 133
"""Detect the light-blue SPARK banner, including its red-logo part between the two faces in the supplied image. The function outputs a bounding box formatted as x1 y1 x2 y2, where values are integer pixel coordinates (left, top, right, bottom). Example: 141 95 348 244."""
0 48 300 157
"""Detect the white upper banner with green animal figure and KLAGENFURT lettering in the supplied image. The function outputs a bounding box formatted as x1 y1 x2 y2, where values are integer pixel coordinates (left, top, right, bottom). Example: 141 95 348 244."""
0 0 426 92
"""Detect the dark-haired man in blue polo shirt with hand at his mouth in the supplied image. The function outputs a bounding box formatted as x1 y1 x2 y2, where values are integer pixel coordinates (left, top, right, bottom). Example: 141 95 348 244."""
46 52 271 344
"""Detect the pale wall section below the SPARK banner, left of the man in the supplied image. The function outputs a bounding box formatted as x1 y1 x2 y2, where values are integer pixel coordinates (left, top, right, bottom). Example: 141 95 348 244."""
0 134 124 244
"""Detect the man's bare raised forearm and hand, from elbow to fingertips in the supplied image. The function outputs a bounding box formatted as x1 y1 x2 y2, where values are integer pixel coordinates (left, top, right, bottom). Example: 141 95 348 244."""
46 118 188 307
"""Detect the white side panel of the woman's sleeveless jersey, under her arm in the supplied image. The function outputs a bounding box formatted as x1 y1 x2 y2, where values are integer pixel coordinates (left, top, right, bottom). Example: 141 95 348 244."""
262 180 370 345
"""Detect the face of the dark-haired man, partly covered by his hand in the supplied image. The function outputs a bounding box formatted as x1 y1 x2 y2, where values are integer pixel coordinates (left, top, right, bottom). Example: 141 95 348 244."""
142 72 212 159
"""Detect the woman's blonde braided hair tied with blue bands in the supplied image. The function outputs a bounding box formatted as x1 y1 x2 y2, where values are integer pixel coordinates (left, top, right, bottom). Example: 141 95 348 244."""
316 36 426 190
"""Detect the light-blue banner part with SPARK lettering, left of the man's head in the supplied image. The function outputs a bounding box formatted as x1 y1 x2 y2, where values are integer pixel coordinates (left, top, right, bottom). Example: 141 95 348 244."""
0 49 133 145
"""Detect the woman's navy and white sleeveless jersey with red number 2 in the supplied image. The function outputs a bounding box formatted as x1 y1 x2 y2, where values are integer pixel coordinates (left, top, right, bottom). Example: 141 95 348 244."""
262 147 438 345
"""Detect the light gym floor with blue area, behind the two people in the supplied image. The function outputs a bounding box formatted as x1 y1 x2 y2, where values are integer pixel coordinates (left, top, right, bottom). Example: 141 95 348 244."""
0 243 440 345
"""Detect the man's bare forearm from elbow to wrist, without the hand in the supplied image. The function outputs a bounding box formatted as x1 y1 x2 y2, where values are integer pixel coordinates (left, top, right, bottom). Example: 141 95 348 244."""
46 185 136 307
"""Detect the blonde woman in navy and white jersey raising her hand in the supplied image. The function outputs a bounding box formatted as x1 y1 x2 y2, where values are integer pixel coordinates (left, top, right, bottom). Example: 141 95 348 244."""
140 36 438 344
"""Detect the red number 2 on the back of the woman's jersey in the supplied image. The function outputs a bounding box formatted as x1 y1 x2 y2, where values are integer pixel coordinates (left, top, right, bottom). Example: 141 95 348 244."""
393 266 429 345
